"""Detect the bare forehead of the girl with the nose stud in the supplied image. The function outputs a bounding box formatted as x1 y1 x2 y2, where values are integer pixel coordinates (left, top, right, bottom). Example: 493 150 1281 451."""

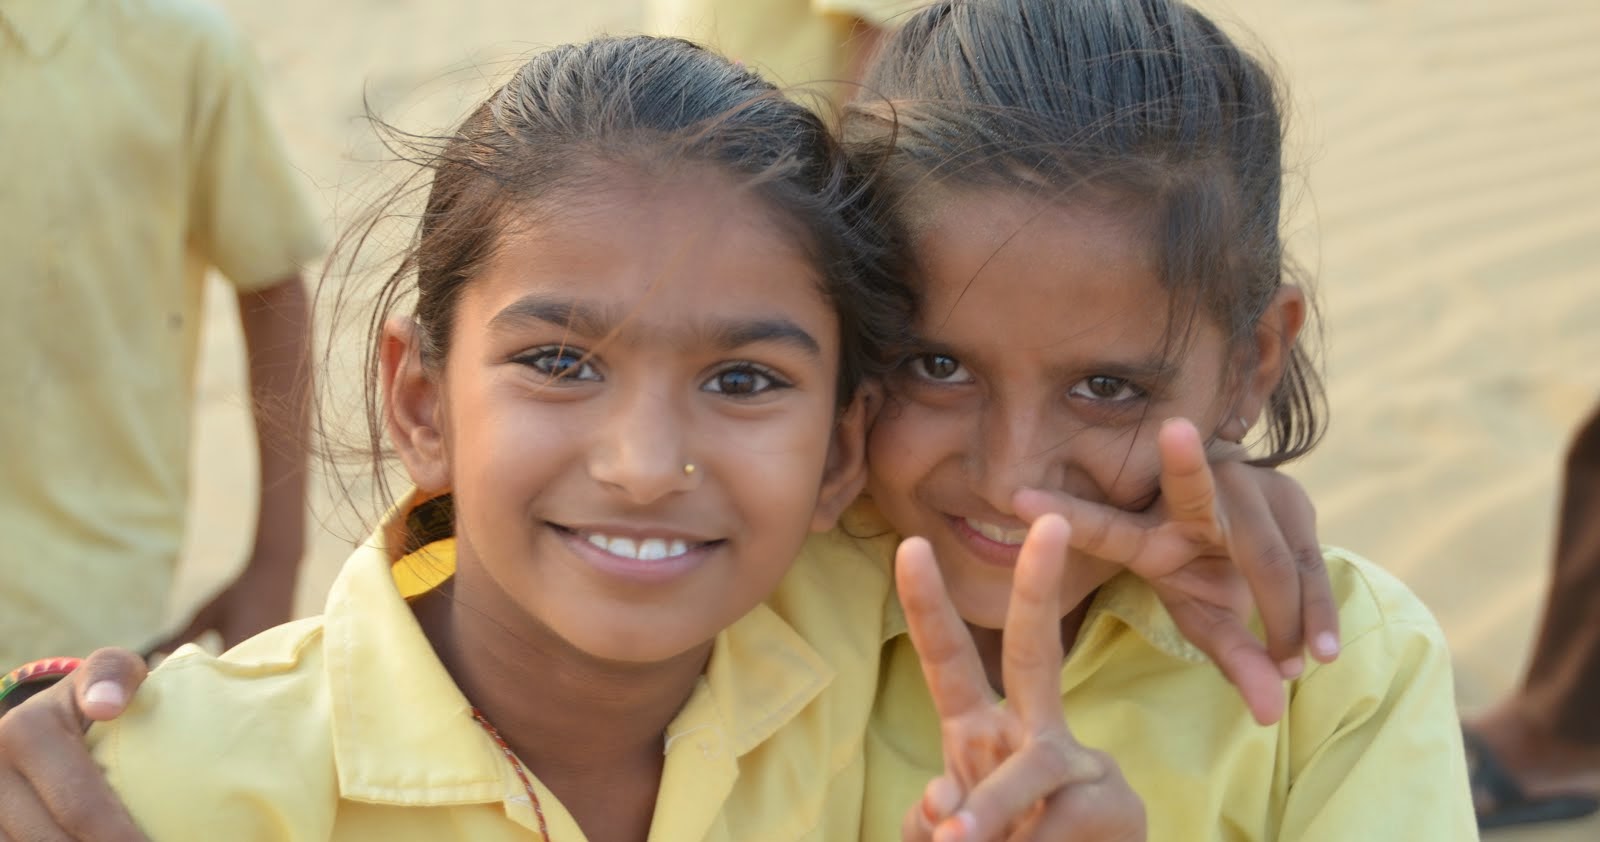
462 186 837 343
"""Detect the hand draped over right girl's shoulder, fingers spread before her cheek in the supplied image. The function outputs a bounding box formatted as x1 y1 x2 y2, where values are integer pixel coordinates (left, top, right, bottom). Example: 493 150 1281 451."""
1014 419 1339 725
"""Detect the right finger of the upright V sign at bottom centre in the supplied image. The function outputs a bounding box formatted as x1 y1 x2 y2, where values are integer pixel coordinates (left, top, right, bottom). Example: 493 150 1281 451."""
1002 514 1072 730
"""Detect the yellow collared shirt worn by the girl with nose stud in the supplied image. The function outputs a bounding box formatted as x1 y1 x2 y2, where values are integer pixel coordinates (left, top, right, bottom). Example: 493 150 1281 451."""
90 502 888 842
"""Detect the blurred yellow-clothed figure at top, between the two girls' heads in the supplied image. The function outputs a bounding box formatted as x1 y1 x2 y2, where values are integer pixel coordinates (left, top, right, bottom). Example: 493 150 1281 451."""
645 0 922 102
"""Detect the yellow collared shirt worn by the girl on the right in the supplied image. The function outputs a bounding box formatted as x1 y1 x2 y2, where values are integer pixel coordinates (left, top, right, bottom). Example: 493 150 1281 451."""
862 549 1477 842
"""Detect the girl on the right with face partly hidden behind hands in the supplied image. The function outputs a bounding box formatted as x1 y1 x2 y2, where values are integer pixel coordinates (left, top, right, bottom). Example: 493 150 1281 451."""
845 0 1475 842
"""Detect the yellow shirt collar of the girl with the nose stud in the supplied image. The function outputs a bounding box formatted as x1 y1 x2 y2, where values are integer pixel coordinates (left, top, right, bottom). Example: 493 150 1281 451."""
325 498 834 805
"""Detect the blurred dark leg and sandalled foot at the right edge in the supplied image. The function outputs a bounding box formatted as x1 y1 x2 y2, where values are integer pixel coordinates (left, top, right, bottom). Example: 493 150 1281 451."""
1464 408 1600 828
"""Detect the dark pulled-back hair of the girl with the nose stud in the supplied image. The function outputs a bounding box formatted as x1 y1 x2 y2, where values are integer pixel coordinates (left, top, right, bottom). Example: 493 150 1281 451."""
323 37 912 515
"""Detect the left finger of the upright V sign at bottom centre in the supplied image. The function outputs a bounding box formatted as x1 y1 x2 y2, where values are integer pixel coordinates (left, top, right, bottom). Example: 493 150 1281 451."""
894 538 994 719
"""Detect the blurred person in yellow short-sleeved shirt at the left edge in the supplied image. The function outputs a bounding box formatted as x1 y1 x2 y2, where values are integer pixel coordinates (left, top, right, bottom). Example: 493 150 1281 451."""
0 0 322 664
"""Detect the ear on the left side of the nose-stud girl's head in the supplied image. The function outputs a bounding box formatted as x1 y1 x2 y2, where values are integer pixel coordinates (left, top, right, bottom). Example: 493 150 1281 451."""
379 317 450 495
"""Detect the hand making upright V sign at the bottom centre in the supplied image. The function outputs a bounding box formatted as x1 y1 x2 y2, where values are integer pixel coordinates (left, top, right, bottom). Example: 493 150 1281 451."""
894 515 1146 842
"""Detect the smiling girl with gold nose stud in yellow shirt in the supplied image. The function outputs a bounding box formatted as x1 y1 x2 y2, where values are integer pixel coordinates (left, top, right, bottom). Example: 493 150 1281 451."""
62 38 907 842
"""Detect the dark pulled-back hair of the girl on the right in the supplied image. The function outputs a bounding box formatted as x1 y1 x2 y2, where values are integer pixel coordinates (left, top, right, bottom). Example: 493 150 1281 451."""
845 0 1325 464
